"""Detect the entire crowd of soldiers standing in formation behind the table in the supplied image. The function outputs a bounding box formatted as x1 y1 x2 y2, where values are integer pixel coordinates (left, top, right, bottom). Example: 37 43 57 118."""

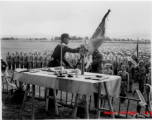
6 45 151 103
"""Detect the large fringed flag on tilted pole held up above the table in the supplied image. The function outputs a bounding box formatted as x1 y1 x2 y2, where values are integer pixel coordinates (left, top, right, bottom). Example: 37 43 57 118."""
87 10 110 54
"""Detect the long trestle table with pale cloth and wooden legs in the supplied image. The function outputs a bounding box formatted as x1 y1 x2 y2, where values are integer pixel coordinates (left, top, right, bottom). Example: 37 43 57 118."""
13 71 121 119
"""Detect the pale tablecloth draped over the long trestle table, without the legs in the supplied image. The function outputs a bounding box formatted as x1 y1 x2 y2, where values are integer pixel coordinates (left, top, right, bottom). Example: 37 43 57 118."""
13 71 121 97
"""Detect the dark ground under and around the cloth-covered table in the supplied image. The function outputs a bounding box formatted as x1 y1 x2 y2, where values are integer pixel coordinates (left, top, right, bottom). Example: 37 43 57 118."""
2 83 146 119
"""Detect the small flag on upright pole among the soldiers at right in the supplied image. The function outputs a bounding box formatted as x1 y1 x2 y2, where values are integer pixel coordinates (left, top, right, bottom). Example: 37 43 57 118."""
130 42 138 66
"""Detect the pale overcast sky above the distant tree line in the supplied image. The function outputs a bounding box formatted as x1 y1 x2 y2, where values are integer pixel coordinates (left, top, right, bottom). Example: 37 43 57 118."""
0 1 151 37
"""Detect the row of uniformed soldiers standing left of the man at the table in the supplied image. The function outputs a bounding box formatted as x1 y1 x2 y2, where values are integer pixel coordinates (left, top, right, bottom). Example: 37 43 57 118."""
6 50 52 70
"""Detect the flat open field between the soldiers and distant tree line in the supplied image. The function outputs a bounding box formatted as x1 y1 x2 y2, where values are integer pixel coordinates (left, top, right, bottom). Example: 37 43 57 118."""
1 40 151 60
